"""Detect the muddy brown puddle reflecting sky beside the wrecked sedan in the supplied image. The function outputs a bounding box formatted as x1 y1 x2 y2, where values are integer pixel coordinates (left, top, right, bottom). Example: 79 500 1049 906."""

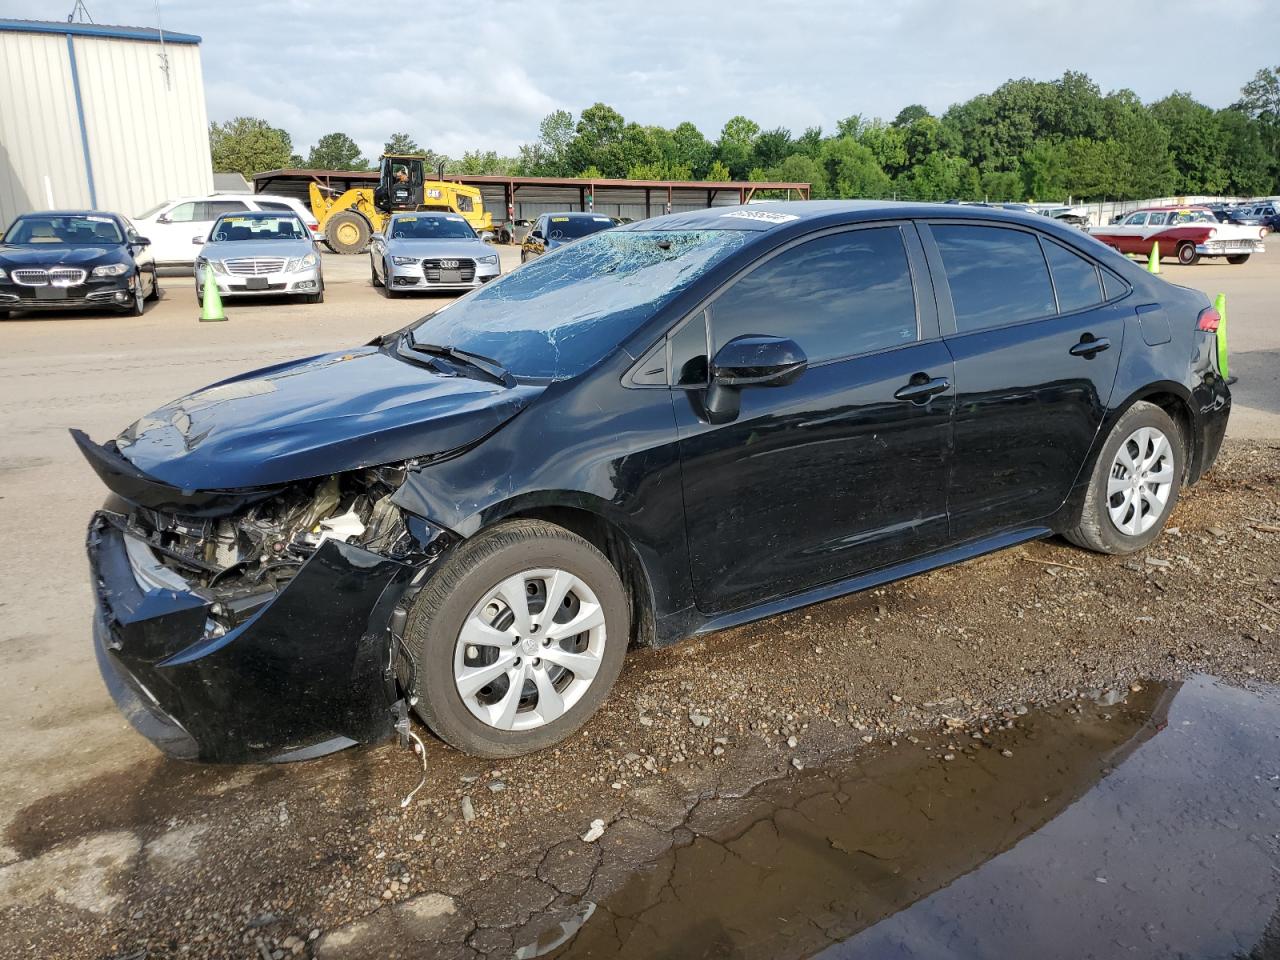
516 677 1280 960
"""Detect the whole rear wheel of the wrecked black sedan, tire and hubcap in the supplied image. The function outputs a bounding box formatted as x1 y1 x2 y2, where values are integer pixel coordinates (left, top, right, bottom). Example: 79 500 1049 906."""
1066 401 1187 554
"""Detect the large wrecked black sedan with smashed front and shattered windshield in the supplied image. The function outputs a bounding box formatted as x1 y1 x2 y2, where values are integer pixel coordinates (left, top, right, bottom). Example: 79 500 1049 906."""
76 202 1231 760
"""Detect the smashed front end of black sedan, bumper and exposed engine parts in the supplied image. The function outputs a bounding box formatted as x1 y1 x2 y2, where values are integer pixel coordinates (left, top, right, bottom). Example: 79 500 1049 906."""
76 434 454 762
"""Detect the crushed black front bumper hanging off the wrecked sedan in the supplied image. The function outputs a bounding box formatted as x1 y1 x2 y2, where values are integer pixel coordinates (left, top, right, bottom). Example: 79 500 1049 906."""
87 511 420 763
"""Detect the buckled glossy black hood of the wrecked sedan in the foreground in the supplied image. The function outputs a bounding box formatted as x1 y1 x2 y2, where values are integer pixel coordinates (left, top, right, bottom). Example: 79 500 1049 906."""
115 347 544 490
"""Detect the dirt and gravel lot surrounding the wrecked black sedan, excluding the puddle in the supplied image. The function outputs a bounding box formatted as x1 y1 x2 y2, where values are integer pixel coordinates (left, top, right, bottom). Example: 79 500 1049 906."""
0 244 1280 960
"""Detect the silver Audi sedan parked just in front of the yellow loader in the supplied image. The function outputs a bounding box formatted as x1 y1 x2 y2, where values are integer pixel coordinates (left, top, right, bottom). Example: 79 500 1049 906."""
369 212 502 297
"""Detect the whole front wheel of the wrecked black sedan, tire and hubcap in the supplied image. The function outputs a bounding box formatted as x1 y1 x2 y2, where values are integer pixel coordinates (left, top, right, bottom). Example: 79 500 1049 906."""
406 520 631 756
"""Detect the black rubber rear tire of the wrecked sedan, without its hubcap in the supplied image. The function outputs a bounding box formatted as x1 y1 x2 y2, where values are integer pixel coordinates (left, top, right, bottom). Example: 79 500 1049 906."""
1065 401 1187 554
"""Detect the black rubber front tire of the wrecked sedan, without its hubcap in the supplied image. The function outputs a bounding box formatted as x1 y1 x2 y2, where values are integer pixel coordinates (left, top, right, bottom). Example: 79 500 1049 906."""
404 520 631 758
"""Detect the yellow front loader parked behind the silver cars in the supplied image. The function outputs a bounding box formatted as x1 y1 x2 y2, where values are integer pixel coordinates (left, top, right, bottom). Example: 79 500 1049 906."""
310 154 493 253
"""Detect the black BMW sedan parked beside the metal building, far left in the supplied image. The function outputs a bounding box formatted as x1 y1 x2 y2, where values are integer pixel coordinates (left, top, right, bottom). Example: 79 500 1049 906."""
0 210 160 319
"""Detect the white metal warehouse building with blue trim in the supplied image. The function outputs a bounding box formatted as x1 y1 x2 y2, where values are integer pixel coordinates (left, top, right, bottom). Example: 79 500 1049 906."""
0 19 214 225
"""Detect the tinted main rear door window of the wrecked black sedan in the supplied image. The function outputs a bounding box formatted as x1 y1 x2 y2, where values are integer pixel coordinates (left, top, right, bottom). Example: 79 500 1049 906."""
932 224 1057 333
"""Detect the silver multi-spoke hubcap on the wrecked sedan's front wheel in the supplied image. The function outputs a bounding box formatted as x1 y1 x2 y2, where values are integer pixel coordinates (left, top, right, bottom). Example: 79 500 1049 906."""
453 568 605 730
